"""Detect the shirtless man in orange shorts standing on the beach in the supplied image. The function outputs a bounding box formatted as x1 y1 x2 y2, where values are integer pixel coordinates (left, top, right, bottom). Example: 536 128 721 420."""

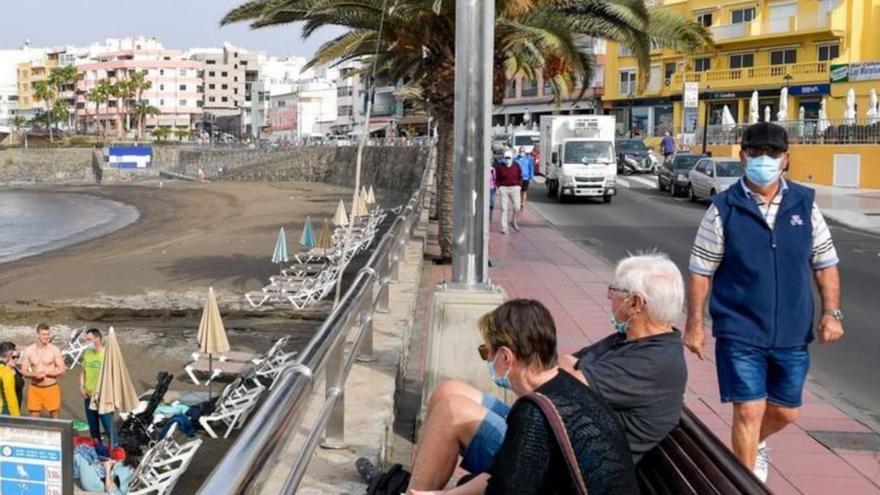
21 323 65 418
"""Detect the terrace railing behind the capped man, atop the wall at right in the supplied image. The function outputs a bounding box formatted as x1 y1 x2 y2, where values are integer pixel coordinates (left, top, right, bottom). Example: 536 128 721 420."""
695 118 880 144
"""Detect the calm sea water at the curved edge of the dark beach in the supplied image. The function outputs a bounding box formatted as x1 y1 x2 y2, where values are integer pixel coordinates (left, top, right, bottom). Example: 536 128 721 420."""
0 191 138 263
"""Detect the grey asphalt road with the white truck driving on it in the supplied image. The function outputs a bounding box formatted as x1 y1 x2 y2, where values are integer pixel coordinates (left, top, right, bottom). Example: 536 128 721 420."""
529 175 880 429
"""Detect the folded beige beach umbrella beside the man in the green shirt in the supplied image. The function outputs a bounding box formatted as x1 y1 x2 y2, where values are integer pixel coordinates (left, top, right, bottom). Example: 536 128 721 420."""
90 327 139 414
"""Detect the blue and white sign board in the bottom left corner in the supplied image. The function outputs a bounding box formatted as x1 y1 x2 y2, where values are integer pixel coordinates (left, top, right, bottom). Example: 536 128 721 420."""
0 416 73 495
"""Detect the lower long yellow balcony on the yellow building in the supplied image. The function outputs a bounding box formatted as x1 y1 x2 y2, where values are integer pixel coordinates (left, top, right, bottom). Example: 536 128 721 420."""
670 62 829 91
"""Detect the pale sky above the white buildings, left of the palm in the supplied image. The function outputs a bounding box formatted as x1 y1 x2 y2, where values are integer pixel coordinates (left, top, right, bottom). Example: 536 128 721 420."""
0 0 344 57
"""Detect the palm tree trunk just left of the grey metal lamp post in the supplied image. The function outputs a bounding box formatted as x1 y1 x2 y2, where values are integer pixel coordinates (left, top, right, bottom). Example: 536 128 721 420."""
437 112 455 263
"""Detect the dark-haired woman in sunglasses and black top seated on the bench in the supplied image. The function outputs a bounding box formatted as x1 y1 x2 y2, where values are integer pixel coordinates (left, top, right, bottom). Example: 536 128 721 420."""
408 299 638 495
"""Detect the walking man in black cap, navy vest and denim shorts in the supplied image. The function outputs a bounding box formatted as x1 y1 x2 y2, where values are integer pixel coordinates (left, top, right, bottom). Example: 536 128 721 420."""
684 122 843 481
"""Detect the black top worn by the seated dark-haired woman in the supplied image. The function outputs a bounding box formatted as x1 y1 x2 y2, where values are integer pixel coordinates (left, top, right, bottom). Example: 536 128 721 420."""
485 370 638 495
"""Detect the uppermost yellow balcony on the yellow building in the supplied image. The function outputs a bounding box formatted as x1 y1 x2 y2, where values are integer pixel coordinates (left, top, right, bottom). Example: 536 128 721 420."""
711 12 845 43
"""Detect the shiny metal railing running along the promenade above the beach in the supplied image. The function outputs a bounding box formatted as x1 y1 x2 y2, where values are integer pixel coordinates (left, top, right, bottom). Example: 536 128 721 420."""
198 156 433 495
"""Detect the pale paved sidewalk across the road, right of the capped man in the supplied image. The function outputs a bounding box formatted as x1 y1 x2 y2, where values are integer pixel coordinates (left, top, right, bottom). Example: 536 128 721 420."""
804 183 880 234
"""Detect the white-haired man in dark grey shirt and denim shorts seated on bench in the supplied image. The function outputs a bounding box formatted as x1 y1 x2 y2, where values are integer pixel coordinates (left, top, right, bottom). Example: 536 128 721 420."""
410 254 687 490
